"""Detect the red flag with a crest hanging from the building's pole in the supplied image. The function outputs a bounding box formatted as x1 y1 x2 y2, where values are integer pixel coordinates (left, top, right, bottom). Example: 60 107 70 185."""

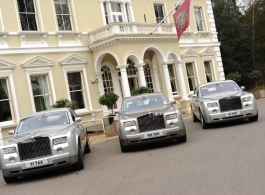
173 0 190 39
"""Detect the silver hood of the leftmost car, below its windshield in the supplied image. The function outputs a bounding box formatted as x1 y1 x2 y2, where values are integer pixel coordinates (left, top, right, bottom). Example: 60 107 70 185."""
3 125 72 146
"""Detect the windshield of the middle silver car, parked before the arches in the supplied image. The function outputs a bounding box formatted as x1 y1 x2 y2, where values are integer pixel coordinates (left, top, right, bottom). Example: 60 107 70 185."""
123 94 169 112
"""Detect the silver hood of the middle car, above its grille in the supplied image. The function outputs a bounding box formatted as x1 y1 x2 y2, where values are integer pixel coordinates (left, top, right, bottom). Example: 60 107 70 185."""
121 106 177 119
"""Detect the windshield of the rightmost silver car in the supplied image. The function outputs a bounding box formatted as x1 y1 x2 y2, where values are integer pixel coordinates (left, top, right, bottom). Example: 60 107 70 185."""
200 82 240 97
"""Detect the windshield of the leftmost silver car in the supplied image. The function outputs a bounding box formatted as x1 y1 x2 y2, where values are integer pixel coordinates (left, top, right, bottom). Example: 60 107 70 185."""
17 111 70 133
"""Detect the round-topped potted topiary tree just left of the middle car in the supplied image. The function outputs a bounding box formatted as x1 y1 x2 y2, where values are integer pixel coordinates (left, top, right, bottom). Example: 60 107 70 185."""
98 92 119 124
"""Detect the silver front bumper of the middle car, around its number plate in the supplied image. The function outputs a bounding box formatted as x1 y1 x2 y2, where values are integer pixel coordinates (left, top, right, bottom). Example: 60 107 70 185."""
120 126 186 146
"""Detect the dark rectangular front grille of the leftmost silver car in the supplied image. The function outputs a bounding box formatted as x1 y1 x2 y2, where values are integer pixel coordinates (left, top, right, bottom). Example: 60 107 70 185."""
18 137 51 160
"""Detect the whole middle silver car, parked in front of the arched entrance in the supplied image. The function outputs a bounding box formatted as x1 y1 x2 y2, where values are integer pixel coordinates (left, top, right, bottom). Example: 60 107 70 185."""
117 93 187 152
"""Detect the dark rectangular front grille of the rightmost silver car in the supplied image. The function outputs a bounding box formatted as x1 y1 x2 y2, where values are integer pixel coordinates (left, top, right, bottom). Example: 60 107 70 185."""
219 96 242 112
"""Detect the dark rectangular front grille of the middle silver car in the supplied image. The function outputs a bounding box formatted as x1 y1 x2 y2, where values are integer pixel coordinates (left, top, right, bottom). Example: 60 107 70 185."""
137 113 165 132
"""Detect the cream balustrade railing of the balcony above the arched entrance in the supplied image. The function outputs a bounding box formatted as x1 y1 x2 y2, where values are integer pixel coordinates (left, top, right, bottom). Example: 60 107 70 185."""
88 23 176 44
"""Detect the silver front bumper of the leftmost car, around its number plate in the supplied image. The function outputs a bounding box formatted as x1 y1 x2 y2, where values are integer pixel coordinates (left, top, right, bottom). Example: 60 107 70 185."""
2 153 78 177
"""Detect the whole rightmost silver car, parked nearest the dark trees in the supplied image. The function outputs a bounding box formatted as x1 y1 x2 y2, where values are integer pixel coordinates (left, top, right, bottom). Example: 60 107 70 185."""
190 80 258 129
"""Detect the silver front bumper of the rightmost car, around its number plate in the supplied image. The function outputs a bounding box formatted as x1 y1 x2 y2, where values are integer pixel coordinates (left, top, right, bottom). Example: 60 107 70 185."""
204 107 258 123
